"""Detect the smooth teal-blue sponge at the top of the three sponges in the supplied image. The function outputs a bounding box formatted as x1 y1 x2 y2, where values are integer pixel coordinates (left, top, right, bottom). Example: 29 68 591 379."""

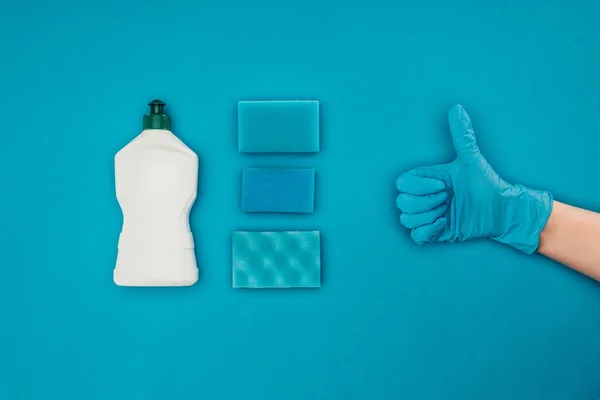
238 101 319 153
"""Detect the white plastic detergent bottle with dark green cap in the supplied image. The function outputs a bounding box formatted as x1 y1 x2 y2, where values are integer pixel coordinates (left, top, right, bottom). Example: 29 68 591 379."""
114 100 198 286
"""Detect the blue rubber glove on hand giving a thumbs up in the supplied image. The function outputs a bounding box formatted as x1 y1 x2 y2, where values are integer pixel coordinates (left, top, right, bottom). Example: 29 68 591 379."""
396 105 553 254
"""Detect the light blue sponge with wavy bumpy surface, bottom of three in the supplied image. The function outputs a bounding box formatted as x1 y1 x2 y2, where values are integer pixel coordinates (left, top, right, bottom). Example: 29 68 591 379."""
232 231 321 288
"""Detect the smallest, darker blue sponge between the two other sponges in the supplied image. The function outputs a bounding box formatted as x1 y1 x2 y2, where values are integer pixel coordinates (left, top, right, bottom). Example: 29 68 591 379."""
242 168 315 213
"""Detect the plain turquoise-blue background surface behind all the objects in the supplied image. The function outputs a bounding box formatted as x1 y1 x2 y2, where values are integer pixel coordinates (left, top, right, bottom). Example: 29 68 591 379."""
0 0 600 400
